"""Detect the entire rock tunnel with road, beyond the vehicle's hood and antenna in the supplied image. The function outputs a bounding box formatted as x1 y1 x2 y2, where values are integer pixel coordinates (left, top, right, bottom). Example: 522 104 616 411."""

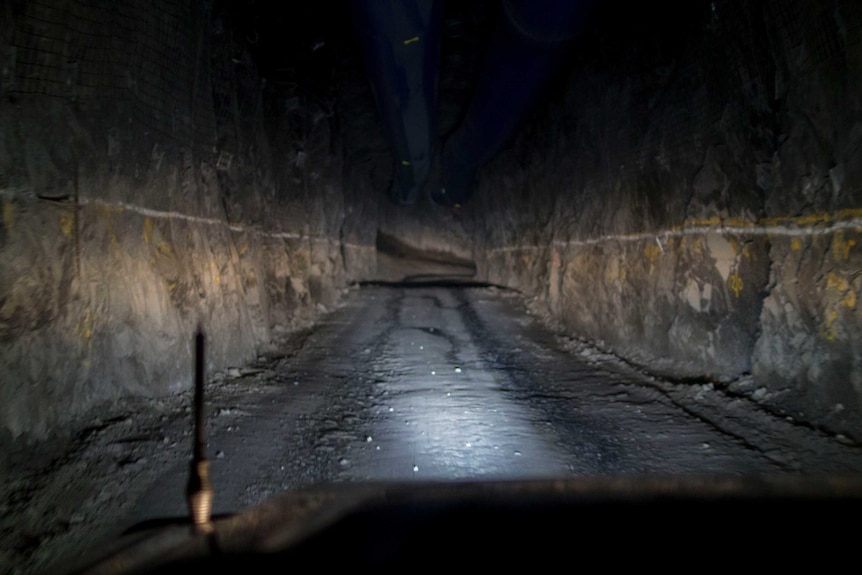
0 0 862 572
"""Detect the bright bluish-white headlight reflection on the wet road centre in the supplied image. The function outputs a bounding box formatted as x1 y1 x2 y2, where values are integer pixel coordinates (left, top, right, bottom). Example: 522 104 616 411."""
355 296 569 480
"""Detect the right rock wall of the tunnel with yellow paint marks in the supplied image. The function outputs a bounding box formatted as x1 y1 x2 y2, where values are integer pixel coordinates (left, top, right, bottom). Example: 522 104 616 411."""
475 0 862 440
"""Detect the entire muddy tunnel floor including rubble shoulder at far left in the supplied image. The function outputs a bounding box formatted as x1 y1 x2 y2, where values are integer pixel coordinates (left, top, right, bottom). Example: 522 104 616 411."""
0 285 862 573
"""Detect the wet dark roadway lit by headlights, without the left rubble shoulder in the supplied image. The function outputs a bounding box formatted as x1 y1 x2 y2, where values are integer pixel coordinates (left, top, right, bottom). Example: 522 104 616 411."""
133 286 862 521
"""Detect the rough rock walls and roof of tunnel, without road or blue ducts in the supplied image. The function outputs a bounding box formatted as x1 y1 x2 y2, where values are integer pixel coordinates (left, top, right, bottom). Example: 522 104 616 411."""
0 0 862 452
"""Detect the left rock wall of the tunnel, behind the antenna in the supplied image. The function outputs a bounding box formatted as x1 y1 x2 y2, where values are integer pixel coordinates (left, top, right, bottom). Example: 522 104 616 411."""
0 0 376 439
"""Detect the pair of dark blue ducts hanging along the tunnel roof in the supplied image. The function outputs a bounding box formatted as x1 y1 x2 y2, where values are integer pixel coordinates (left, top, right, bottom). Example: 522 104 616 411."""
352 0 591 206
